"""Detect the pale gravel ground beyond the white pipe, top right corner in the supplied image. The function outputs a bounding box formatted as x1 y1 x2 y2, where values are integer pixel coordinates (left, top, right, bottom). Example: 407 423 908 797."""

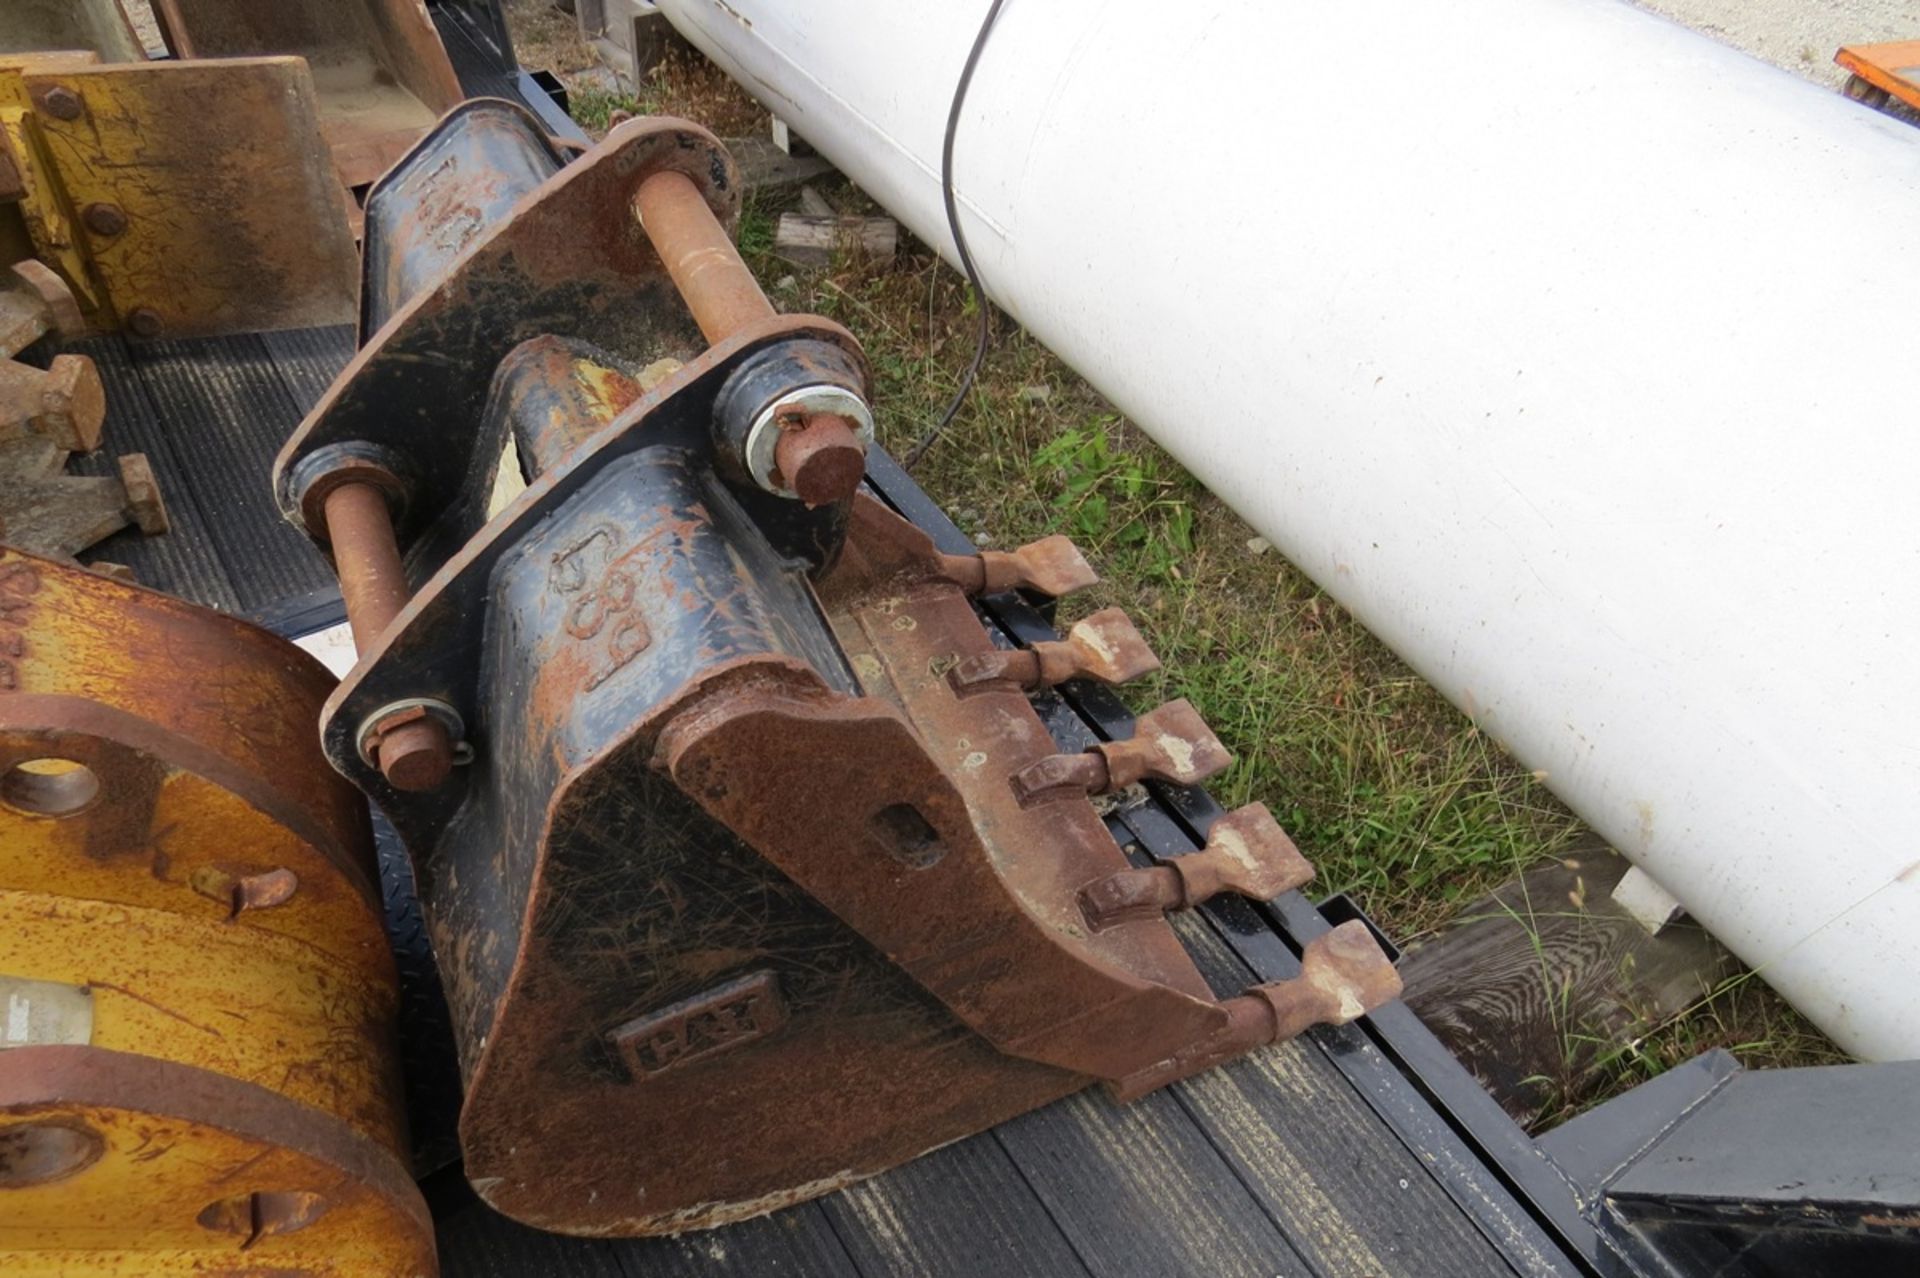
1638 0 1920 88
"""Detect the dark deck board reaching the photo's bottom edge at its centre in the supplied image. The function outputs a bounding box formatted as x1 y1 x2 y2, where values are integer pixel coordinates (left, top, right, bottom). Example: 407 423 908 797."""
820 1134 1089 1278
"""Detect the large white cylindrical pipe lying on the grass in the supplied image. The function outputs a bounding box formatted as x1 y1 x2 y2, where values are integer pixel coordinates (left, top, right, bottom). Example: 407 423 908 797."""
662 0 1920 1059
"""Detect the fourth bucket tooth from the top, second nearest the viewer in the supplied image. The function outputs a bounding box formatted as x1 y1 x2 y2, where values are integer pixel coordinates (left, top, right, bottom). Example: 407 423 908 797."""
1079 804 1313 929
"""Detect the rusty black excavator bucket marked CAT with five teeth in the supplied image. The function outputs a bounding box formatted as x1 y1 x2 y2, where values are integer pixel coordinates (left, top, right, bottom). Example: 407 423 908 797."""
275 102 1398 1234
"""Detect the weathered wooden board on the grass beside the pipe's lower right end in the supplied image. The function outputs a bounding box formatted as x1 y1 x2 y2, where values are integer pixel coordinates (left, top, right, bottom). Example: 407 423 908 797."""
1400 835 1738 1124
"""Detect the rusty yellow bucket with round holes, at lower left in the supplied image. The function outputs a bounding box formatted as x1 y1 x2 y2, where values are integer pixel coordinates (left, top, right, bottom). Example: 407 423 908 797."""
0 547 436 1278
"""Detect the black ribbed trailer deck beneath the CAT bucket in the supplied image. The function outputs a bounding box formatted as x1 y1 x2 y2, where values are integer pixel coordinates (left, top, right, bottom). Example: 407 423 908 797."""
37 6 1594 1278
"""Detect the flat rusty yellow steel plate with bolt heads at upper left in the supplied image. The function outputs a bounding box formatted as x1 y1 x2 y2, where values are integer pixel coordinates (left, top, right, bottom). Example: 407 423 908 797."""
0 54 355 338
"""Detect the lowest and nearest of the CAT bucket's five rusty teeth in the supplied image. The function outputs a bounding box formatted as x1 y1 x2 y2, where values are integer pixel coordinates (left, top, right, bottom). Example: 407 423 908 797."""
1108 919 1402 1101
